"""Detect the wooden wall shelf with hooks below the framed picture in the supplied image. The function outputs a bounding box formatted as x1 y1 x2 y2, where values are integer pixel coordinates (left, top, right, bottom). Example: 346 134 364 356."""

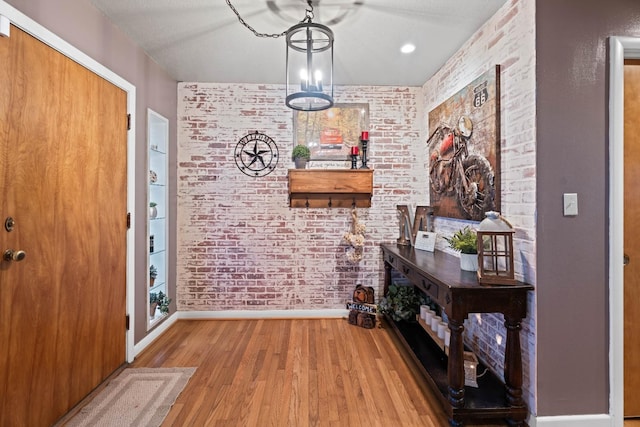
289 169 373 208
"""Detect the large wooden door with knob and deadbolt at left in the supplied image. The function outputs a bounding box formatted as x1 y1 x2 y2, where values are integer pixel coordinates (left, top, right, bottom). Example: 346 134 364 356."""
0 27 127 426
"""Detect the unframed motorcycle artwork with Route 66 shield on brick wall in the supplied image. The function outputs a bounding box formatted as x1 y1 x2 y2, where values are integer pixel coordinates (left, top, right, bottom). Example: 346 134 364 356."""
427 65 500 221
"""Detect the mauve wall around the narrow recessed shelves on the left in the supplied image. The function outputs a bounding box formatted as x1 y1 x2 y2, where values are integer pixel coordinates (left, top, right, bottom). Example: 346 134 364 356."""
7 0 177 343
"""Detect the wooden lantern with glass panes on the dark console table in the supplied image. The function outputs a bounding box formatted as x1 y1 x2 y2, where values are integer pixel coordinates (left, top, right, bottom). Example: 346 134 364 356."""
477 212 516 285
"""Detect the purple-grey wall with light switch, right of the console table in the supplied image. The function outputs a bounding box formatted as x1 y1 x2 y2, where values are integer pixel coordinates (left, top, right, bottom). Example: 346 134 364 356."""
536 0 640 416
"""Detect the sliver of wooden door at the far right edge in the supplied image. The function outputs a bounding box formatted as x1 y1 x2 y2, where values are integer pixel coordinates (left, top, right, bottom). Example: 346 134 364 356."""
624 60 640 417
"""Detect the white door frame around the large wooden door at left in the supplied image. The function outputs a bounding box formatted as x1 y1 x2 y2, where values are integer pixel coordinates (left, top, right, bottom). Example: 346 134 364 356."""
0 0 136 363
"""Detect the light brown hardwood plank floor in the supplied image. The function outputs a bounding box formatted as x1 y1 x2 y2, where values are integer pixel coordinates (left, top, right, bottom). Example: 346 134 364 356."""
132 319 516 427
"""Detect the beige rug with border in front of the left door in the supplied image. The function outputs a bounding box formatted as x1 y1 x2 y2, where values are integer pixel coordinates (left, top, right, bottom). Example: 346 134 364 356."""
65 368 196 427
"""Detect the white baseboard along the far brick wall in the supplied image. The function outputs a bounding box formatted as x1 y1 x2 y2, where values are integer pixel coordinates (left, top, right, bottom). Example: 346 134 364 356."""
178 309 349 320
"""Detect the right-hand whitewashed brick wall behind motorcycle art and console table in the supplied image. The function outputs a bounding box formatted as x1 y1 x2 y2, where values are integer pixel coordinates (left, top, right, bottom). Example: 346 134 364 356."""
422 0 536 413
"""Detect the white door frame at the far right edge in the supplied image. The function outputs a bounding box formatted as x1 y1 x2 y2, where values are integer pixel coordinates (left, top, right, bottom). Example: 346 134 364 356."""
609 37 640 426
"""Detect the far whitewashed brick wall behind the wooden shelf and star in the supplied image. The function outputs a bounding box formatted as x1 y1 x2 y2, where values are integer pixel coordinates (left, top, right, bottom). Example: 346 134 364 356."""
177 83 427 311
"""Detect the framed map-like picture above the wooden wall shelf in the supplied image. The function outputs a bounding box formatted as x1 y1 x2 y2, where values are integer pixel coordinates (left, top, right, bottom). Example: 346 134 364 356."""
293 103 369 160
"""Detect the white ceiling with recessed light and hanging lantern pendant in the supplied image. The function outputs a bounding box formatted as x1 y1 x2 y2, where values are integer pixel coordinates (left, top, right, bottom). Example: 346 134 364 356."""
91 0 506 86
